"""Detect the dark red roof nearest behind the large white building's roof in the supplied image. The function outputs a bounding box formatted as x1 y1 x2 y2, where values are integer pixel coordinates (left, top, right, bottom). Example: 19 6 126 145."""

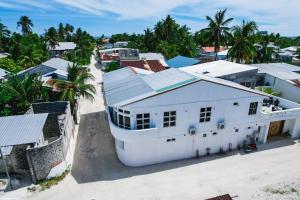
121 60 166 72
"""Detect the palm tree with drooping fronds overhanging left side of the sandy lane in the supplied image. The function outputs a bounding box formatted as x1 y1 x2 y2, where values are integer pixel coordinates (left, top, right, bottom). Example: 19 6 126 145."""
51 63 96 106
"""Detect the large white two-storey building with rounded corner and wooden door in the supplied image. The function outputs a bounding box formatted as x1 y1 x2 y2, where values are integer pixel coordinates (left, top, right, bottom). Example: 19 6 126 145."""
103 67 300 166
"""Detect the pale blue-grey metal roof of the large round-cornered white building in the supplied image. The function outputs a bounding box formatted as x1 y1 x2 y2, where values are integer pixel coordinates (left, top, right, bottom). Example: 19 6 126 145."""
103 67 267 106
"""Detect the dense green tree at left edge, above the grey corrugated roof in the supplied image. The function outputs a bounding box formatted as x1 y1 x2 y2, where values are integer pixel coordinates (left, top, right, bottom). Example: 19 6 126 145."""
0 74 46 115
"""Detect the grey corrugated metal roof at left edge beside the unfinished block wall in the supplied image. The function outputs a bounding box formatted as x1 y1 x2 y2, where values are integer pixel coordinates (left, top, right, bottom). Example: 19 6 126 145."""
0 113 48 146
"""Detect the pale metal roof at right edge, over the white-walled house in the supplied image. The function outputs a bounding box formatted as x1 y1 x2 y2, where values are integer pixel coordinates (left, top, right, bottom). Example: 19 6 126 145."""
252 63 300 81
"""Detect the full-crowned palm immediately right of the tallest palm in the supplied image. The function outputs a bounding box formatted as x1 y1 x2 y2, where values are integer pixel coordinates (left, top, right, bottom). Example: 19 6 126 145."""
228 21 257 63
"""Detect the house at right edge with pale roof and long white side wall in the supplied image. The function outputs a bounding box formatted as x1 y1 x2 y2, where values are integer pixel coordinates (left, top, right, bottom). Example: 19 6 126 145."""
251 63 300 103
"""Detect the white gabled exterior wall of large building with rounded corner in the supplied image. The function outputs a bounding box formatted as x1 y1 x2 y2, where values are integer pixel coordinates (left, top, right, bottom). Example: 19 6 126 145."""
109 81 267 166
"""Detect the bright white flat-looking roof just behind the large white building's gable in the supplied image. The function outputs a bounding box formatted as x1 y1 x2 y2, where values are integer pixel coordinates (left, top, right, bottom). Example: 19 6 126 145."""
180 60 257 77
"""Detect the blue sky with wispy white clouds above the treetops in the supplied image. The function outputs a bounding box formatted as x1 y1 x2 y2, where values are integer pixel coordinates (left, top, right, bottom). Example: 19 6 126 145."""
0 0 300 36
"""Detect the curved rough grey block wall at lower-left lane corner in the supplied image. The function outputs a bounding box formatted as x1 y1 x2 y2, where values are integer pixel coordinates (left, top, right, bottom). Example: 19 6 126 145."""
27 137 64 182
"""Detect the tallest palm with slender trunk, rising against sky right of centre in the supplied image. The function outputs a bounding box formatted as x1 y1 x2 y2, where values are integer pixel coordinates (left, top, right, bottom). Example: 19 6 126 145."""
202 9 233 60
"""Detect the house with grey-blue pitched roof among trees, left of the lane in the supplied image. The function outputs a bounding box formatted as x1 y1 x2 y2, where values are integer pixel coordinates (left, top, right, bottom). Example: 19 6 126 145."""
18 58 73 81
